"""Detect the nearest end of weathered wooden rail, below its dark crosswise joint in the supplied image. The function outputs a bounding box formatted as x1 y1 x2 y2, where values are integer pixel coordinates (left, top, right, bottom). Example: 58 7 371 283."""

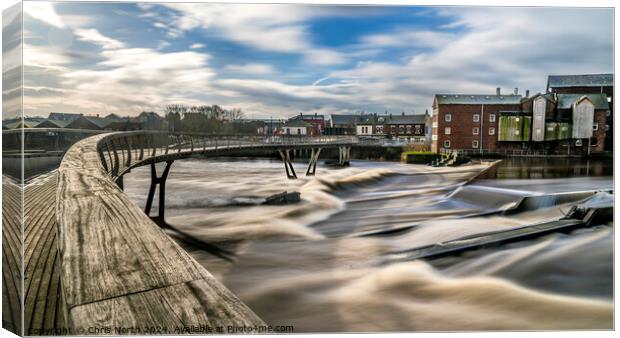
70 279 262 334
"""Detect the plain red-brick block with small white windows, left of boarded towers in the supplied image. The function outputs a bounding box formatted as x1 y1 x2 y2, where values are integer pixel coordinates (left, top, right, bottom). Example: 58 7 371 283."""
431 88 522 152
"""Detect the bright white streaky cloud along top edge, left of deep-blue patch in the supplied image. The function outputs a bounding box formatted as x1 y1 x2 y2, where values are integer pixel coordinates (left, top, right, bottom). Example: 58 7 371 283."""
143 3 347 65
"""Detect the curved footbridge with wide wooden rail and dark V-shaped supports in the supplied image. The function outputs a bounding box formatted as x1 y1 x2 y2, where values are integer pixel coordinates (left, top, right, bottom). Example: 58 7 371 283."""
55 132 356 334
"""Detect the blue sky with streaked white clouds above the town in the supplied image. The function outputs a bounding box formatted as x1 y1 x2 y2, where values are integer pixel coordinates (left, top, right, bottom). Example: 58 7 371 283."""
3 2 613 118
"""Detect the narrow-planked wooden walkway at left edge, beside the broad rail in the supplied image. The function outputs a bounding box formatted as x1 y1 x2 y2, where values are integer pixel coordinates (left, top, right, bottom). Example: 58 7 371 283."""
2 173 66 335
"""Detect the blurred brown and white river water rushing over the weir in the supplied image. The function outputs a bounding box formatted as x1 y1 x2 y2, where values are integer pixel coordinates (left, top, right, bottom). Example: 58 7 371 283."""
125 158 613 332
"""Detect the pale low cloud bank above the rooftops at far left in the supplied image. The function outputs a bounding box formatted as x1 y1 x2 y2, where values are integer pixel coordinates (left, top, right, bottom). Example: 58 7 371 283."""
24 30 215 114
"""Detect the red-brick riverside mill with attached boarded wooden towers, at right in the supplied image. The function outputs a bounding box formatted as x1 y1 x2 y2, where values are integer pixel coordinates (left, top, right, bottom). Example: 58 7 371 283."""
431 84 611 155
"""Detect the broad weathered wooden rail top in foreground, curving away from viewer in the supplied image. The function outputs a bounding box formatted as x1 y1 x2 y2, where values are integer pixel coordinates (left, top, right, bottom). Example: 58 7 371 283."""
56 135 264 335
